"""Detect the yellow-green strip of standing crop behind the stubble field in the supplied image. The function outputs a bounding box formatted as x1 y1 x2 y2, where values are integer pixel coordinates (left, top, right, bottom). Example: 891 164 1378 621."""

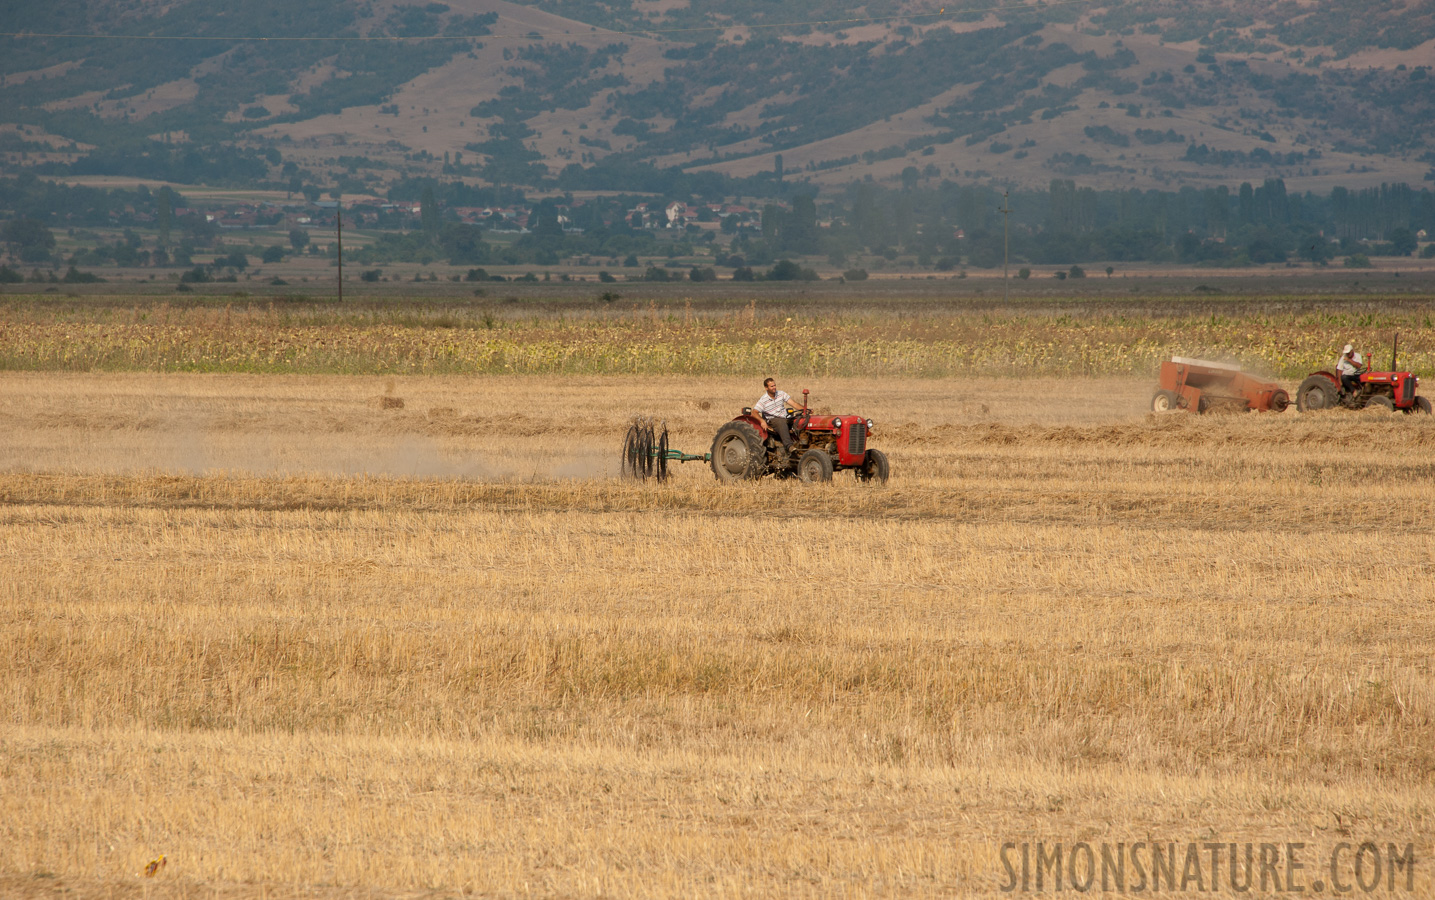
0 297 1435 379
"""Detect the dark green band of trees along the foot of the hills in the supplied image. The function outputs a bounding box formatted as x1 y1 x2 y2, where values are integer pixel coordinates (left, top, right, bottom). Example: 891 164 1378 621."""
8 179 1435 270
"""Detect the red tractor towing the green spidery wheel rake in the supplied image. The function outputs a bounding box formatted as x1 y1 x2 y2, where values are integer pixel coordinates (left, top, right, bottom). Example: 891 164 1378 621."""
709 390 890 482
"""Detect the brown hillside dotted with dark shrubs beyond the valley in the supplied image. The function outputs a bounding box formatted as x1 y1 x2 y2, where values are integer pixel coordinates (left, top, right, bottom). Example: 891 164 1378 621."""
0 0 1435 194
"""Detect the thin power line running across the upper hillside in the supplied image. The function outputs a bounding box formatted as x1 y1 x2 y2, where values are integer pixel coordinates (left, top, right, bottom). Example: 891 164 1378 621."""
0 0 1095 43
